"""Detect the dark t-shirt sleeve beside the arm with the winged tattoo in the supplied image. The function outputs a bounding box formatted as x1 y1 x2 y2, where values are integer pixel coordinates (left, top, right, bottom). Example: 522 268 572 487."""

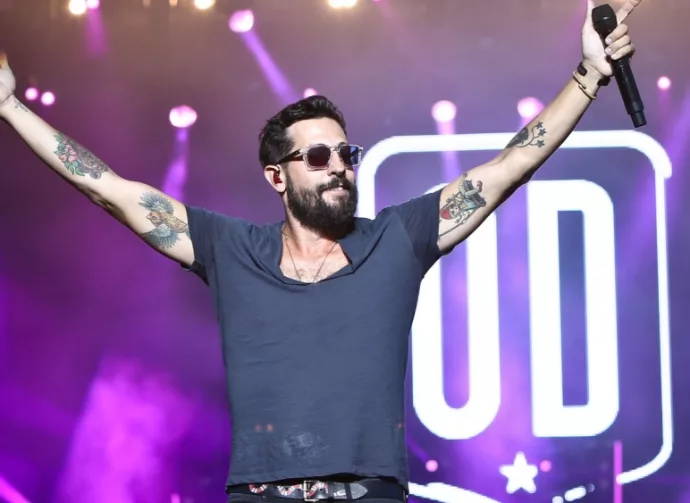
186 206 232 283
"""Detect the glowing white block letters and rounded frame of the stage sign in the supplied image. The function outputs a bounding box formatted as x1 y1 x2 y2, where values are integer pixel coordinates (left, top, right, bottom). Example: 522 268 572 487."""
358 131 673 491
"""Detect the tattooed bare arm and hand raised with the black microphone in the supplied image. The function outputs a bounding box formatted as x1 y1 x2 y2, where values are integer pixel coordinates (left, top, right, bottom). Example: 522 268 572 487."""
438 0 642 252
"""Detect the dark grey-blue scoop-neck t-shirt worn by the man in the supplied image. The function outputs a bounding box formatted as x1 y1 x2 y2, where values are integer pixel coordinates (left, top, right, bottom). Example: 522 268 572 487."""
187 191 441 492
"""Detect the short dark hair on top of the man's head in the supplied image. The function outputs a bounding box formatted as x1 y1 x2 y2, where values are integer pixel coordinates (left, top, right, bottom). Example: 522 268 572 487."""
259 96 347 168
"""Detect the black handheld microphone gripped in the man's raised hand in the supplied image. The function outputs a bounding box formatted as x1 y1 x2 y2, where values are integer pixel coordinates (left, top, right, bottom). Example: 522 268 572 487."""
592 4 647 128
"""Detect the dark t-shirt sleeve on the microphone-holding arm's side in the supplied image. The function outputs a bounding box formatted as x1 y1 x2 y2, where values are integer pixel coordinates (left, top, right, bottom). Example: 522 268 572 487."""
387 189 443 274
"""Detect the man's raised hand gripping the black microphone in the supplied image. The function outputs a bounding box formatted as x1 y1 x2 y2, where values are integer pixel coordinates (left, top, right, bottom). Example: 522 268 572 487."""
582 0 642 77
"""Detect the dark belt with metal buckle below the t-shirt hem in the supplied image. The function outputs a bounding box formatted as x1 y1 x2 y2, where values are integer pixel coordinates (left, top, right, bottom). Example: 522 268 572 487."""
226 479 407 501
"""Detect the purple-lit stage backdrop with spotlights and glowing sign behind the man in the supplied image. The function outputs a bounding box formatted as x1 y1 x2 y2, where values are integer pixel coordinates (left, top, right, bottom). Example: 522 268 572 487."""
0 0 690 503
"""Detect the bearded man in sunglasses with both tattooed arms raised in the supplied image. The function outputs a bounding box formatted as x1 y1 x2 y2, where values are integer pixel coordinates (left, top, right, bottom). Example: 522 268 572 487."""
0 0 641 503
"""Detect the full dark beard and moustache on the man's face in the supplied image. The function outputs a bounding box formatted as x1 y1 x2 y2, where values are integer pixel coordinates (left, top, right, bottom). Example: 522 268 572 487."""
285 173 358 237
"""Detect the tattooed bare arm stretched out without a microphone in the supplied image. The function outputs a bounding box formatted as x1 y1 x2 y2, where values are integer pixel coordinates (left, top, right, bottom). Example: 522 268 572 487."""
0 55 194 266
